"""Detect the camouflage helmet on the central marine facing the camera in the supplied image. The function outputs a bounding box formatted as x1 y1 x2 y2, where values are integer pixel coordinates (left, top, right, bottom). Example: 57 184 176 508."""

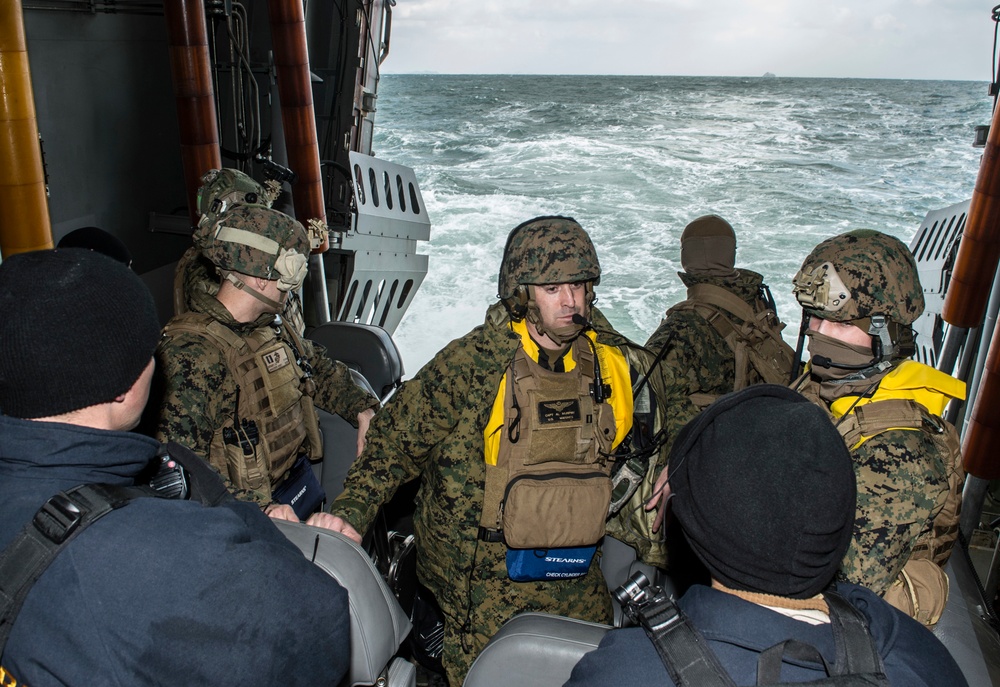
498 217 601 301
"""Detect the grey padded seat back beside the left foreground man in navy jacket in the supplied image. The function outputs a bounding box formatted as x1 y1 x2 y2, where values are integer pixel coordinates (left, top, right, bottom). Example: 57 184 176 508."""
272 520 416 687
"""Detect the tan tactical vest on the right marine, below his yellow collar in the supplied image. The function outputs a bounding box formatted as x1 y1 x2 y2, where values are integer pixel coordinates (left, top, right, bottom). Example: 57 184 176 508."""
837 399 965 626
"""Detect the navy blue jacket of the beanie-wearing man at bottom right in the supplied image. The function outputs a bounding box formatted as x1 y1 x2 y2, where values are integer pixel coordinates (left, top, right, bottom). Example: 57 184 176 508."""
566 584 967 687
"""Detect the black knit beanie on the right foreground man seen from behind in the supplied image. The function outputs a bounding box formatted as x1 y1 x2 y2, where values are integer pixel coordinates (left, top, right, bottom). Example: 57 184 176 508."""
668 384 857 599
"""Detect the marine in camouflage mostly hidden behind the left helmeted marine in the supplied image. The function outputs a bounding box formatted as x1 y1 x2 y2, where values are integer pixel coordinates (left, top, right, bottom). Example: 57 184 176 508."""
174 168 306 336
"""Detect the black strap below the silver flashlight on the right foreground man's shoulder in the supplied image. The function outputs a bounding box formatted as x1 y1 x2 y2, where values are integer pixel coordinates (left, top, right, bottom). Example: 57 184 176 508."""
639 595 736 687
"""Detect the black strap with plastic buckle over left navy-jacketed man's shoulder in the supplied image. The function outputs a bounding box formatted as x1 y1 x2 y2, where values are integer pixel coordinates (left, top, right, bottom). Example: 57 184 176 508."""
0 484 156 655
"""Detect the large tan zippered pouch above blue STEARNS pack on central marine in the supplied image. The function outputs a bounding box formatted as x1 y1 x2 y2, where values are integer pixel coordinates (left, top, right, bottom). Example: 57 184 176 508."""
500 471 611 549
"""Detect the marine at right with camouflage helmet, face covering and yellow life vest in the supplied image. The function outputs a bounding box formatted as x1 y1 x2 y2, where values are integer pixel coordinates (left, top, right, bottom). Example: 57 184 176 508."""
793 230 965 624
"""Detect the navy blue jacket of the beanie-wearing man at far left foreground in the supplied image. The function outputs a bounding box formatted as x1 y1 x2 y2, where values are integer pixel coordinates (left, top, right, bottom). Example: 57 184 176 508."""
0 416 350 687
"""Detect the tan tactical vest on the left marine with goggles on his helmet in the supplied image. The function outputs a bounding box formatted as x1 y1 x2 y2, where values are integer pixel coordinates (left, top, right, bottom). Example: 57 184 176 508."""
164 312 323 494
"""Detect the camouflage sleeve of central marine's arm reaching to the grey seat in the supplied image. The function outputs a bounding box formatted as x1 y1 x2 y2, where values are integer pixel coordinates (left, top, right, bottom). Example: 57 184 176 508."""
330 339 492 533
